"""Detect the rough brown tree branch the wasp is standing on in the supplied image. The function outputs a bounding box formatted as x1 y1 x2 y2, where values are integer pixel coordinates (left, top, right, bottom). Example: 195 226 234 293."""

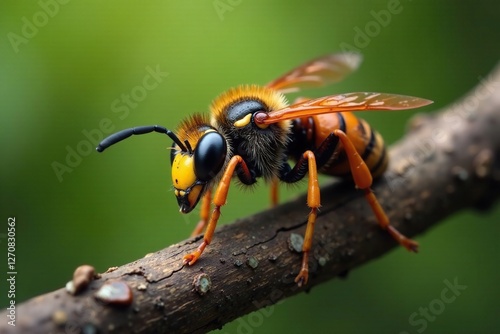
0 66 500 333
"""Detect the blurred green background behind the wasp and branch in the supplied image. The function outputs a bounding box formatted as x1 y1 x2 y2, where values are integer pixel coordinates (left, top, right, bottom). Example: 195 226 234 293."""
0 0 500 333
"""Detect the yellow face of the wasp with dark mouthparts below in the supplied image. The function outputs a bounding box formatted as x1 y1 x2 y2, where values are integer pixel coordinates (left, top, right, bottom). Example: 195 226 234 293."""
172 153 205 213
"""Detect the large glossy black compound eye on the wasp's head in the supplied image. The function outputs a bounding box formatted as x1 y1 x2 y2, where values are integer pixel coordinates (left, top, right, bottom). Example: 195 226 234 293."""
194 131 227 181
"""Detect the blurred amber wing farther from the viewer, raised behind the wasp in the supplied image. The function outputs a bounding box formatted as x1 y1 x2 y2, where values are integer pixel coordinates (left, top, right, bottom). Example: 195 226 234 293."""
267 52 362 93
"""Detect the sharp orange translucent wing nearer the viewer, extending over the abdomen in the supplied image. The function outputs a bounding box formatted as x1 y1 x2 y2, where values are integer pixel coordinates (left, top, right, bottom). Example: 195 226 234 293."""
255 92 432 124
